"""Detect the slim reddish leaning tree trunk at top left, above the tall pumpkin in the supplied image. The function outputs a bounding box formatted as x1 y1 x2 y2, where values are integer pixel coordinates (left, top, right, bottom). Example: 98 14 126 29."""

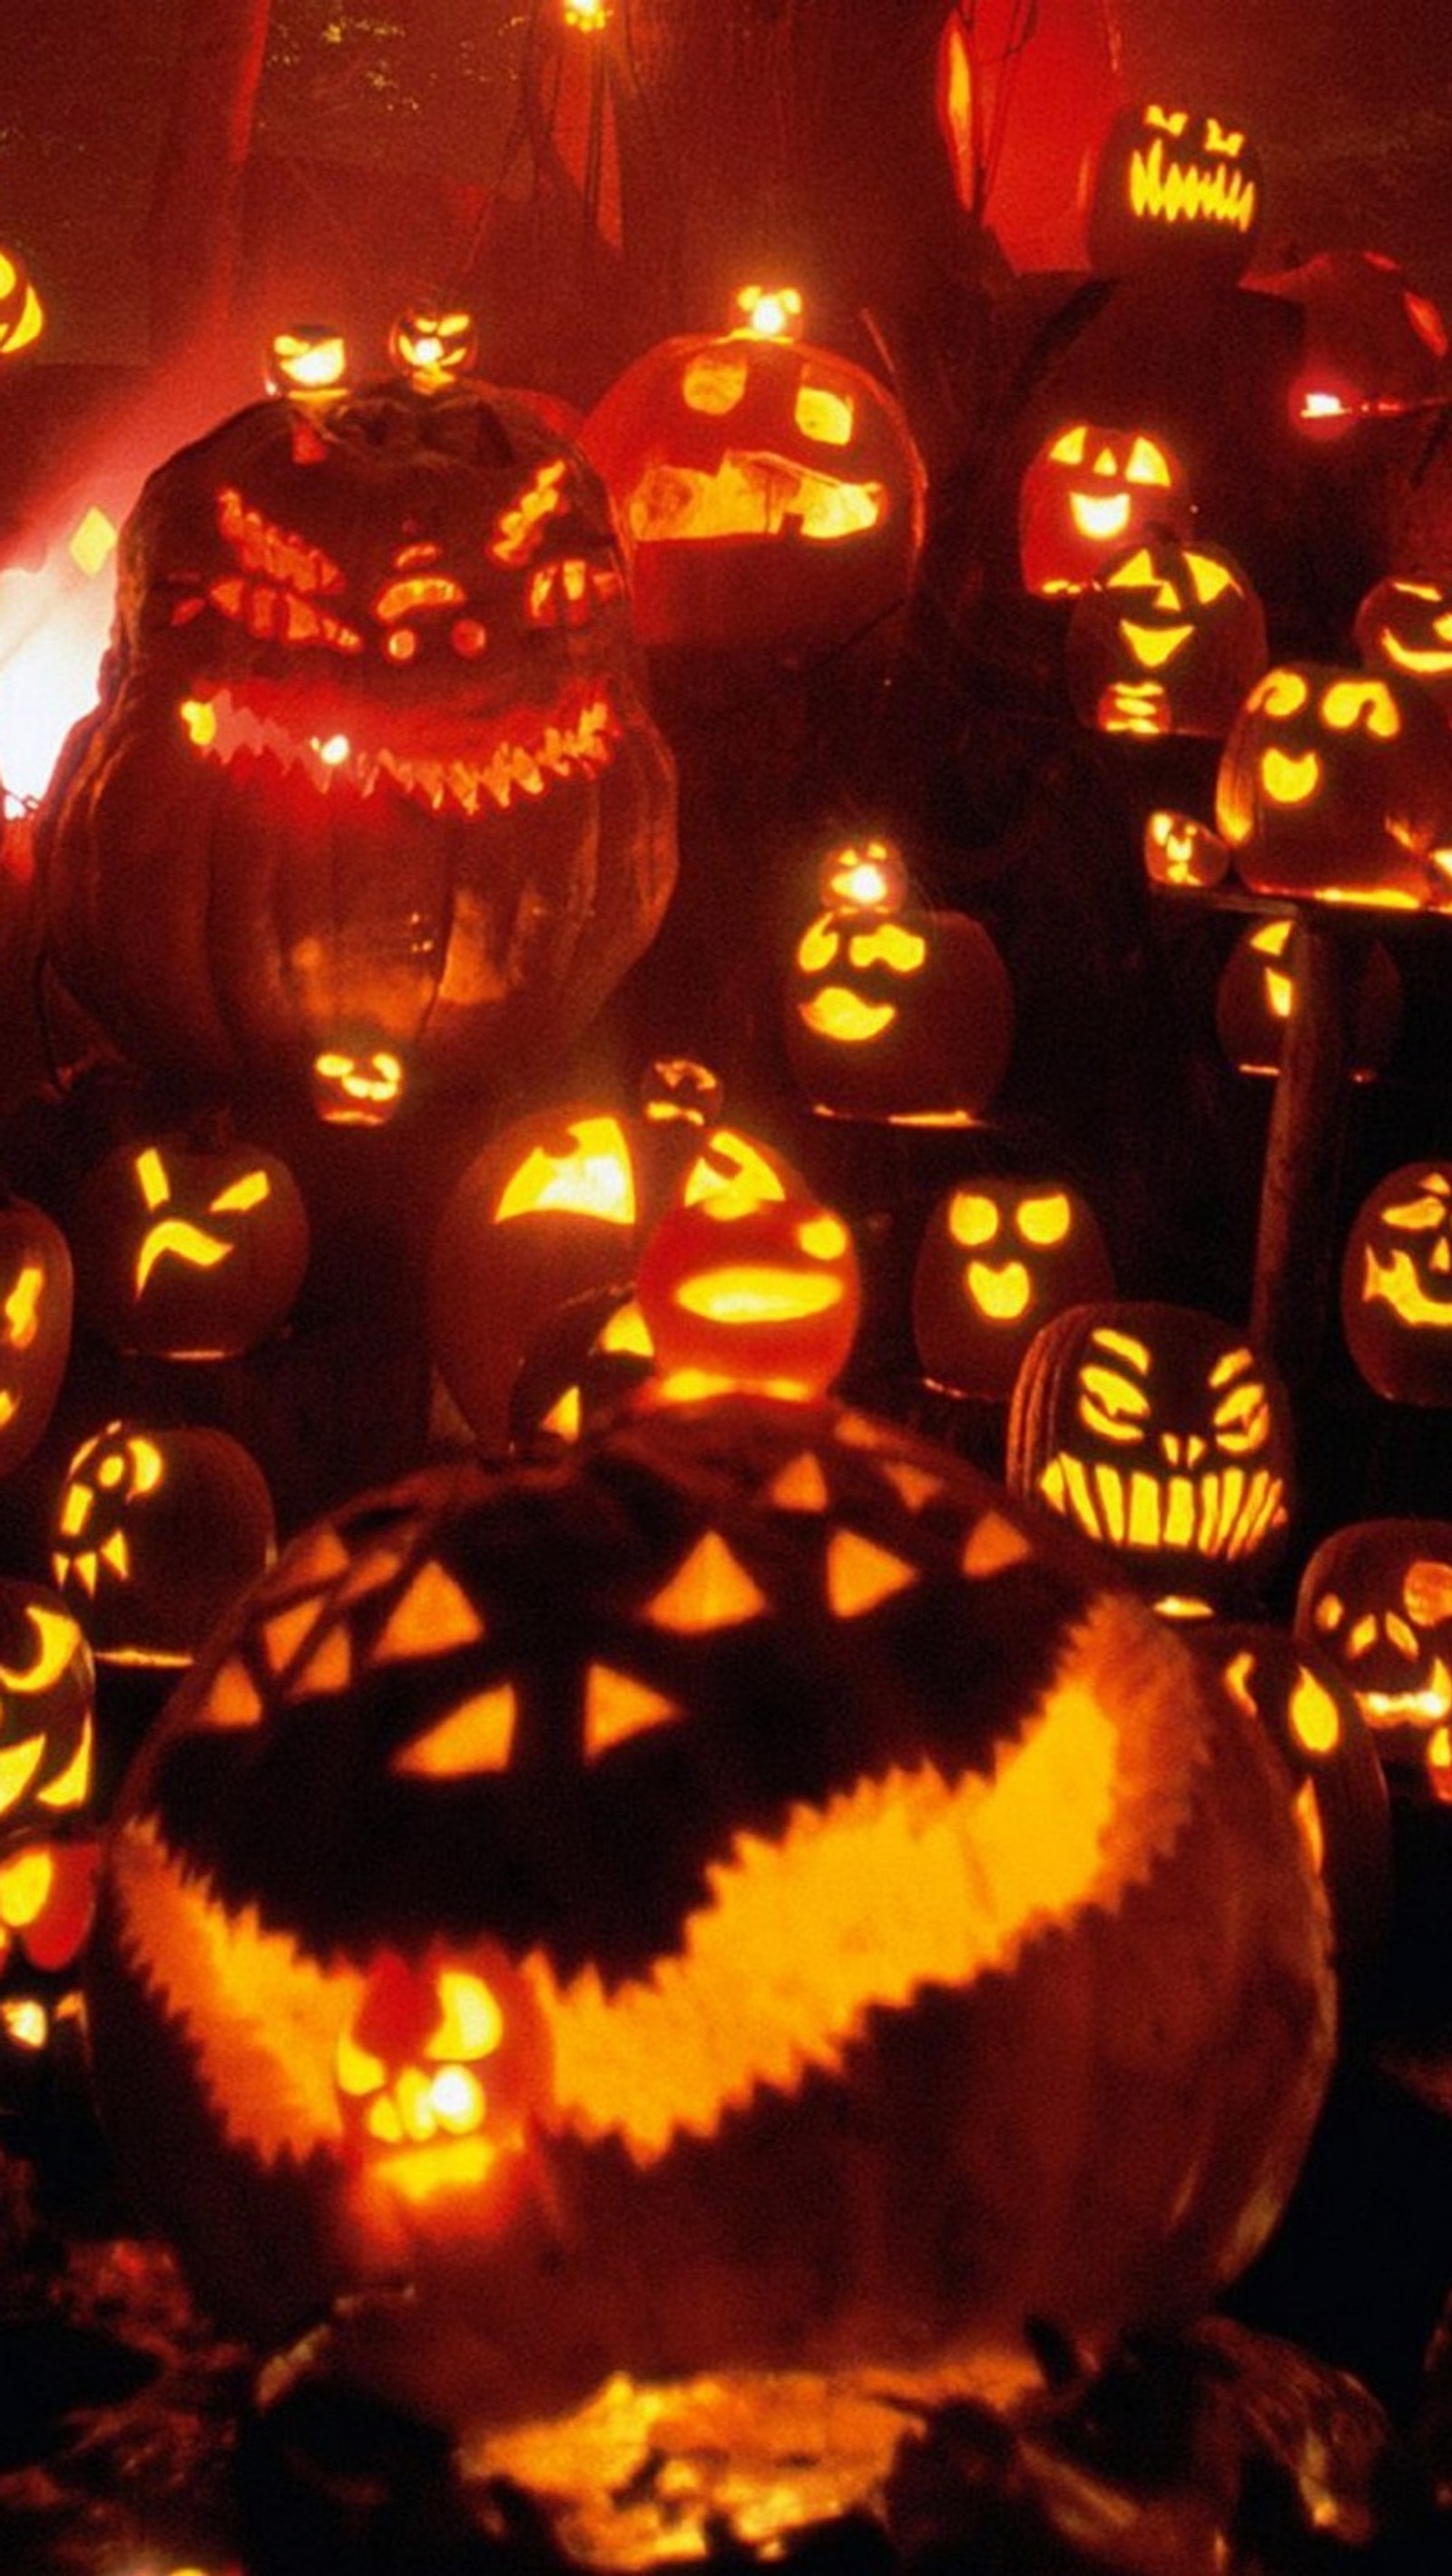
150 0 270 369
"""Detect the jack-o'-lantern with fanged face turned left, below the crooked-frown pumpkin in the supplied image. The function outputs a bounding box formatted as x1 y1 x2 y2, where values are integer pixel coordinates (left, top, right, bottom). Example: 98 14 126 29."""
52 1420 276 1664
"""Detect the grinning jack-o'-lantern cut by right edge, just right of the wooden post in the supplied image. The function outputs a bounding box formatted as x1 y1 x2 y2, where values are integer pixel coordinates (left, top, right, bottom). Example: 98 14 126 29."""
1341 1162 1452 1404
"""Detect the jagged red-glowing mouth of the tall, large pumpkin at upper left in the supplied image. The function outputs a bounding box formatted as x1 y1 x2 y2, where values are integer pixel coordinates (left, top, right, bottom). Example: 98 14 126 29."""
181 688 621 817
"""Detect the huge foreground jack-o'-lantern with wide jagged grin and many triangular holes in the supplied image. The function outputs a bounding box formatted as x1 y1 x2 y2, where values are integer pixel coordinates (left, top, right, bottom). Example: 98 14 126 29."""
87 1396 1334 2424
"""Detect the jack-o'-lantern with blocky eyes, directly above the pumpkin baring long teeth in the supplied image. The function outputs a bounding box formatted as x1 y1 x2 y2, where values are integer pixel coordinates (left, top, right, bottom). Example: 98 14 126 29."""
911 1172 1114 1401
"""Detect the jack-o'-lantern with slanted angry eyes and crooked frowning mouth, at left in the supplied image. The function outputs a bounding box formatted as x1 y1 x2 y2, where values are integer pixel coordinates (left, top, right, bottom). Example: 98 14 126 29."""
72 1134 309 1360
